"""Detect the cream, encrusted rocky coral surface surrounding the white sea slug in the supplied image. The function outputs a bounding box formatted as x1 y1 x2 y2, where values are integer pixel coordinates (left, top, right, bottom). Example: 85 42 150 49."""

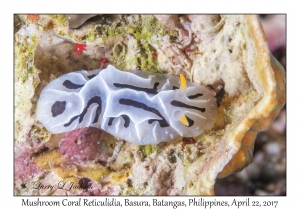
15 15 285 195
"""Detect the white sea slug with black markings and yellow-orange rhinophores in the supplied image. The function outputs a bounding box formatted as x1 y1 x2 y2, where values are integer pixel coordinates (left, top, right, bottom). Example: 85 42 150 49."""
36 65 217 145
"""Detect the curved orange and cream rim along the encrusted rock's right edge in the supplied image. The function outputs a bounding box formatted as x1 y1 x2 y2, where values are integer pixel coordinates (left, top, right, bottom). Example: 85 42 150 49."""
218 16 286 178
